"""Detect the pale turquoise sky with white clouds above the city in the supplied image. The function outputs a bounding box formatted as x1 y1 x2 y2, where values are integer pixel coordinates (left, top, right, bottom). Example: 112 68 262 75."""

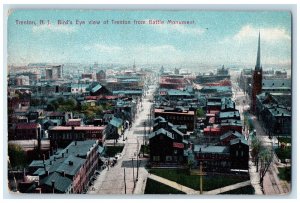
7 10 291 66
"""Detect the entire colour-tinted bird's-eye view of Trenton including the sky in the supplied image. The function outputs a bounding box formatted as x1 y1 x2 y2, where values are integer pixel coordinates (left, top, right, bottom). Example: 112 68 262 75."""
7 10 292 195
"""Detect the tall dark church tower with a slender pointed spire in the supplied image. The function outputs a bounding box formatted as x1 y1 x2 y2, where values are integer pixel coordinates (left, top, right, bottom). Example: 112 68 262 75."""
251 33 262 112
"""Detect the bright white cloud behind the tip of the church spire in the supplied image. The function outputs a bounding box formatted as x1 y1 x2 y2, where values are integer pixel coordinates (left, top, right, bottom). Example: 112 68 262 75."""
232 25 291 43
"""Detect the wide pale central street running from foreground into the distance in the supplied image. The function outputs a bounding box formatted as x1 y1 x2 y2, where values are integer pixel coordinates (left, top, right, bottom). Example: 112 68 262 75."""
87 84 153 195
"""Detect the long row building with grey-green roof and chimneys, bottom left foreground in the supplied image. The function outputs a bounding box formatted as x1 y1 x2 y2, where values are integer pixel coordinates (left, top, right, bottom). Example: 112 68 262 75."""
26 140 101 194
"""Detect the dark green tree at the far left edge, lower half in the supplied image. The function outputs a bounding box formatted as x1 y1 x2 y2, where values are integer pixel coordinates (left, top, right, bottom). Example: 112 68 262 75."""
8 144 27 168
